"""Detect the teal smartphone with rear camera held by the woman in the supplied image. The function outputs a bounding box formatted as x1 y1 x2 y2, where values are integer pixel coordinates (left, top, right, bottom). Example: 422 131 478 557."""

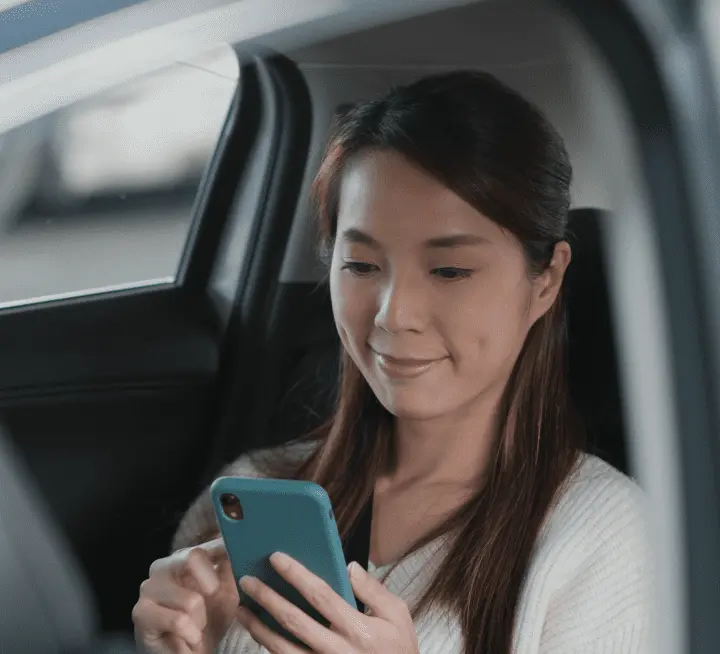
210 477 357 645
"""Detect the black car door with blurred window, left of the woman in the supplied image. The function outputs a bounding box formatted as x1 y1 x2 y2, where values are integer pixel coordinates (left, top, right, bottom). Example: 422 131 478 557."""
0 42 308 630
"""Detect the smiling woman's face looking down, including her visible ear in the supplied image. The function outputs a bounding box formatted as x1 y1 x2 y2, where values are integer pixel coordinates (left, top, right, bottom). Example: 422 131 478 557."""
330 151 570 419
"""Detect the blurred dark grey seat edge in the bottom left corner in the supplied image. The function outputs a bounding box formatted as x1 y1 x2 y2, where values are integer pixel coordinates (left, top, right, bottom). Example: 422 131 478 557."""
0 428 136 654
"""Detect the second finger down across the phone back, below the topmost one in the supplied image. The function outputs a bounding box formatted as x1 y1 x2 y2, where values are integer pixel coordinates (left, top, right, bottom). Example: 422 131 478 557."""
241 577 344 652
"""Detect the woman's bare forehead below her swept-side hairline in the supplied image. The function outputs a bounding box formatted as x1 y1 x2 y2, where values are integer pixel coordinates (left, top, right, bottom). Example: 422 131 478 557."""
338 150 500 242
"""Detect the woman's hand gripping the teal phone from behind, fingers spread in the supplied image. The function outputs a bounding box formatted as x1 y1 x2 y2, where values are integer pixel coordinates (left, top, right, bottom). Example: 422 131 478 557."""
238 553 418 654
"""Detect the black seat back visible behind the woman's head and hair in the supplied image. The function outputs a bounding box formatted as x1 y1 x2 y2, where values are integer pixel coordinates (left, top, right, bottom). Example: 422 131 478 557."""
267 209 627 472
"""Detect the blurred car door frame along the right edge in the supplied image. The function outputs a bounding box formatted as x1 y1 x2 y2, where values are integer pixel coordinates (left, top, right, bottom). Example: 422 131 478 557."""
560 0 720 654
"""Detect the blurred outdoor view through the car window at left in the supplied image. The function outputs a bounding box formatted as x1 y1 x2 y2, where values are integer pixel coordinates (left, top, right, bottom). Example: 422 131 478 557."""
0 48 239 307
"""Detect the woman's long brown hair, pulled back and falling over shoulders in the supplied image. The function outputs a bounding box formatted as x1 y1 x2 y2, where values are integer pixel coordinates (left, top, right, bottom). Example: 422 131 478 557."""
253 71 584 654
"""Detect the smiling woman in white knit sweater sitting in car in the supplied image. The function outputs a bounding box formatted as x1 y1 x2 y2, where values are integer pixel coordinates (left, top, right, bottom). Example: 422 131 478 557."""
134 72 651 654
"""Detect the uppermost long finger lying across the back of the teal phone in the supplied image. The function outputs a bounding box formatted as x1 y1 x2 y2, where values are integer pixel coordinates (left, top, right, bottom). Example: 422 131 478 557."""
270 552 362 633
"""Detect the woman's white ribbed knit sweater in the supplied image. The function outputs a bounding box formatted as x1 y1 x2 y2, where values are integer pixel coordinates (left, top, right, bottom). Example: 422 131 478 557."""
173 446 654 654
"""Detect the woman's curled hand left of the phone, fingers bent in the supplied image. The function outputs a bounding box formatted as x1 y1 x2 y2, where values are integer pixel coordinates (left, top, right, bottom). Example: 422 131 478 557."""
132 539 240 654
